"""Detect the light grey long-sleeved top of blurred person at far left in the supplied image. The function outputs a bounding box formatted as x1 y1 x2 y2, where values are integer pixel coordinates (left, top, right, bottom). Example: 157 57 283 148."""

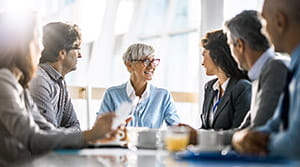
0 69 84 162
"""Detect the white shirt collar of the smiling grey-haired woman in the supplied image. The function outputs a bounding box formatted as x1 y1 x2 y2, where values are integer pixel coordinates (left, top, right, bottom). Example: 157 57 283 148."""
126 80 151 103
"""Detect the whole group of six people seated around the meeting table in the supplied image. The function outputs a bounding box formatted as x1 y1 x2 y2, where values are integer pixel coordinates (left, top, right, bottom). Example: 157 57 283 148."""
0 0 300 164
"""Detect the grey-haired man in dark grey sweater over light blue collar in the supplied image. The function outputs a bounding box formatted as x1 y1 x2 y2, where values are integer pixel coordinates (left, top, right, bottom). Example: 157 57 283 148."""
217 10 289 145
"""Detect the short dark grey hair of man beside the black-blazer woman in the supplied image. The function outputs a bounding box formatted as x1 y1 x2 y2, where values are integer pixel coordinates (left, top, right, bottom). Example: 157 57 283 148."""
225 10 270 51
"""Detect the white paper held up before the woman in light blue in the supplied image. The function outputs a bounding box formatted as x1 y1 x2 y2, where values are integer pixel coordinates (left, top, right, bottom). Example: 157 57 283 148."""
112 102 132 129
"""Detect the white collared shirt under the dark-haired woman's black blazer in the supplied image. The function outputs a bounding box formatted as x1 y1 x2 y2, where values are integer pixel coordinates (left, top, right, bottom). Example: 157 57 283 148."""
209 78 230 126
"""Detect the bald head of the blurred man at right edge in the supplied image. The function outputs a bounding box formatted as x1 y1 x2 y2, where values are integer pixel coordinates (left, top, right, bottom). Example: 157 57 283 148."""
262 0 300 53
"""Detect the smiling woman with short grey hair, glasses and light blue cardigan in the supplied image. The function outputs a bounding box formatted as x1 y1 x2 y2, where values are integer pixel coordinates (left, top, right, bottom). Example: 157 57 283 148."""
97 43 179 128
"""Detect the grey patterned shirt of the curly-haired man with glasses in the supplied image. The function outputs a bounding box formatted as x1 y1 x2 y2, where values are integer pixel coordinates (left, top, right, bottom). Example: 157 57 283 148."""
29 63 80 131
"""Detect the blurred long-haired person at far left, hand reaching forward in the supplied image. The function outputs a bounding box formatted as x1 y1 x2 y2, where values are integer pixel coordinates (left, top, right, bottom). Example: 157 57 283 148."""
0 13 114 166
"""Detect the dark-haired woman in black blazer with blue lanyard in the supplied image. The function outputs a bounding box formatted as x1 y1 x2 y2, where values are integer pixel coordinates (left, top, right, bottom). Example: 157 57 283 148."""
201 30 251 130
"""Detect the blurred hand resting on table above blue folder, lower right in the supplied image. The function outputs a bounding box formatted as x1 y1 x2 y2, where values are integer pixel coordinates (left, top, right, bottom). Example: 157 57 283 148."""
232 129 269 155
